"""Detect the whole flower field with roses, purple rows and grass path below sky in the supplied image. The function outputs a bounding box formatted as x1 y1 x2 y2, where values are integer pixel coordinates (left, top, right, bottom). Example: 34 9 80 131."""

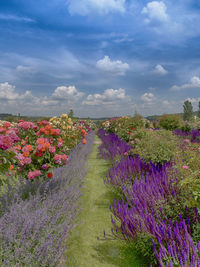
0 114 200 267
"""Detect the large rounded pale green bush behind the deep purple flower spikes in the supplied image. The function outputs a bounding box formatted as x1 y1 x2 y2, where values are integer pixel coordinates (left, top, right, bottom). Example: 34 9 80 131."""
132 130 177 164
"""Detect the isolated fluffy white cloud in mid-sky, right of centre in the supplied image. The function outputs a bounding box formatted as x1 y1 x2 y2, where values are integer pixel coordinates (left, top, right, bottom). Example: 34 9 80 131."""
96 56 129 76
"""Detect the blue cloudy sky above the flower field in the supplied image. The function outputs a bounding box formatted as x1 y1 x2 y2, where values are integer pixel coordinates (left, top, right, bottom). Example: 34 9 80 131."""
0 0 200 118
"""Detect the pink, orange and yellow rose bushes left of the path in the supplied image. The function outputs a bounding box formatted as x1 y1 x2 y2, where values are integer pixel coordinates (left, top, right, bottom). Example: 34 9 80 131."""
0 114 90 180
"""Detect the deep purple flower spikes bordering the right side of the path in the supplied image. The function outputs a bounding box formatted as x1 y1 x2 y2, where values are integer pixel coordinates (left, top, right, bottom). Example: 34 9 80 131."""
99 130 200 267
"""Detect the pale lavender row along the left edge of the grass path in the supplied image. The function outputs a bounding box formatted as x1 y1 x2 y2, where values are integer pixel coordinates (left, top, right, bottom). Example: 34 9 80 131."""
0 133 94 267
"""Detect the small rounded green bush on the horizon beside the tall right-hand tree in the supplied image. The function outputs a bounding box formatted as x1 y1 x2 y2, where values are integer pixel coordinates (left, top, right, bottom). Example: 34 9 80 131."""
159 114 182 131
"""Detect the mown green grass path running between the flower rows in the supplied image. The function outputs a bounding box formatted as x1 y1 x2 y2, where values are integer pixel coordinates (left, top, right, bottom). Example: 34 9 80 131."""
66 137 145 267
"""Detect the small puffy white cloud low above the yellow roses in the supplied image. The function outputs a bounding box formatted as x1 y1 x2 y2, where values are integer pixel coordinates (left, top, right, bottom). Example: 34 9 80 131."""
52 86 84 101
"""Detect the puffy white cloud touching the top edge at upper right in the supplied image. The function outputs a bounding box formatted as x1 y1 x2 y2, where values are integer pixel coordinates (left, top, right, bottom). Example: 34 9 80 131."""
142 1 168 23
